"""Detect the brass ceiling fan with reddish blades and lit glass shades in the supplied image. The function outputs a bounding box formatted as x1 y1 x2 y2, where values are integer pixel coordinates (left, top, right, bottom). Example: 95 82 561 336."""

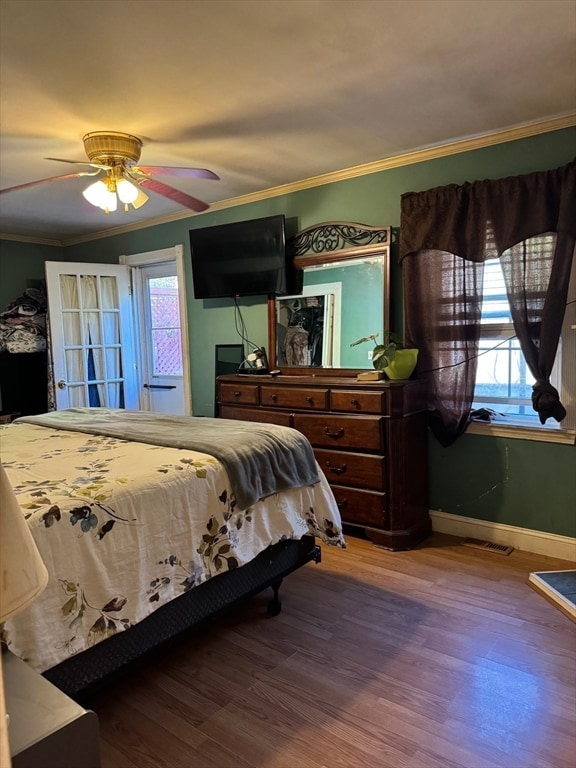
0 131 219 213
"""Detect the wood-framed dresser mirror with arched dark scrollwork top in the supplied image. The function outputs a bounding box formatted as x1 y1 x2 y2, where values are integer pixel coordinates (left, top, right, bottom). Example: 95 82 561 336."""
268 221 391 375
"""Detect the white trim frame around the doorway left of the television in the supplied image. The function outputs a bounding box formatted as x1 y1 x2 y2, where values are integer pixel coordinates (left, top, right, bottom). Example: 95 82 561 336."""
119 244 193 416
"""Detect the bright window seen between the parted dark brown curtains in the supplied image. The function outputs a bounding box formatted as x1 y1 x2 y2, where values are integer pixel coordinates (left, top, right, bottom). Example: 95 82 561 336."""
473 235 576 430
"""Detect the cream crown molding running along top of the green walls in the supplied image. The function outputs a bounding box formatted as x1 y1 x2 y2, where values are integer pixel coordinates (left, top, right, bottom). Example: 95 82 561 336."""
0 113 576 247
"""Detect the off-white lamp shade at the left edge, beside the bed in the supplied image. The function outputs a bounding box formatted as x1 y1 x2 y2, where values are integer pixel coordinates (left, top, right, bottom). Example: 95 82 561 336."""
0 464 48 622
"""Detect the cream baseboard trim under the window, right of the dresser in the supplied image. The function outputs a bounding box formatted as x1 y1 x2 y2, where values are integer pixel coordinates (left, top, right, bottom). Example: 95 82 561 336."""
430 510 576 563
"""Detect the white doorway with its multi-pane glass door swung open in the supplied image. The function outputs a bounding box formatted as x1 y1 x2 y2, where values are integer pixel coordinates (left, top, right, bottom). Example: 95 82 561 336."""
46 245 192 415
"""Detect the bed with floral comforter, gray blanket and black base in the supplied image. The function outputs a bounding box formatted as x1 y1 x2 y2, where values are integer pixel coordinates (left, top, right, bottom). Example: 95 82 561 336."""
0 408 345 696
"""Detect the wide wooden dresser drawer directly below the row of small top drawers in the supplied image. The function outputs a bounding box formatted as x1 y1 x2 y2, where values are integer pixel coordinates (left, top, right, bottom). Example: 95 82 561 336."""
294 413 384 451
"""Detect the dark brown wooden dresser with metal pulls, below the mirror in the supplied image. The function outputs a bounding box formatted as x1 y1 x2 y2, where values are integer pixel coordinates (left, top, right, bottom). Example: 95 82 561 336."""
217 375 431 550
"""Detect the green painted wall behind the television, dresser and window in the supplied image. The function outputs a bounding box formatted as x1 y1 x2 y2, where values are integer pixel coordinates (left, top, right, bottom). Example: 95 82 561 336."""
0 128 576 536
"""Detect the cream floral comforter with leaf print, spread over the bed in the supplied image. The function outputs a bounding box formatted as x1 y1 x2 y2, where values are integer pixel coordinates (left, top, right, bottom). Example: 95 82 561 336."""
0 423 345 672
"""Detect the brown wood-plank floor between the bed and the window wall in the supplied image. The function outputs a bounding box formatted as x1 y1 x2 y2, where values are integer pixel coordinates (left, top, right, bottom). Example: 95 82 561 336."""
90 534 576 768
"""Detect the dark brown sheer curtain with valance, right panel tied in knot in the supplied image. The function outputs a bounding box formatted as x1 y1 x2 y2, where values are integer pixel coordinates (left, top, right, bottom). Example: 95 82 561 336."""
400 161 576 446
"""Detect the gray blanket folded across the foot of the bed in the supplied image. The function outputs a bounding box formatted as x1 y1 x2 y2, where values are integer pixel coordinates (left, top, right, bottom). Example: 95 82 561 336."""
15 408 320 509
